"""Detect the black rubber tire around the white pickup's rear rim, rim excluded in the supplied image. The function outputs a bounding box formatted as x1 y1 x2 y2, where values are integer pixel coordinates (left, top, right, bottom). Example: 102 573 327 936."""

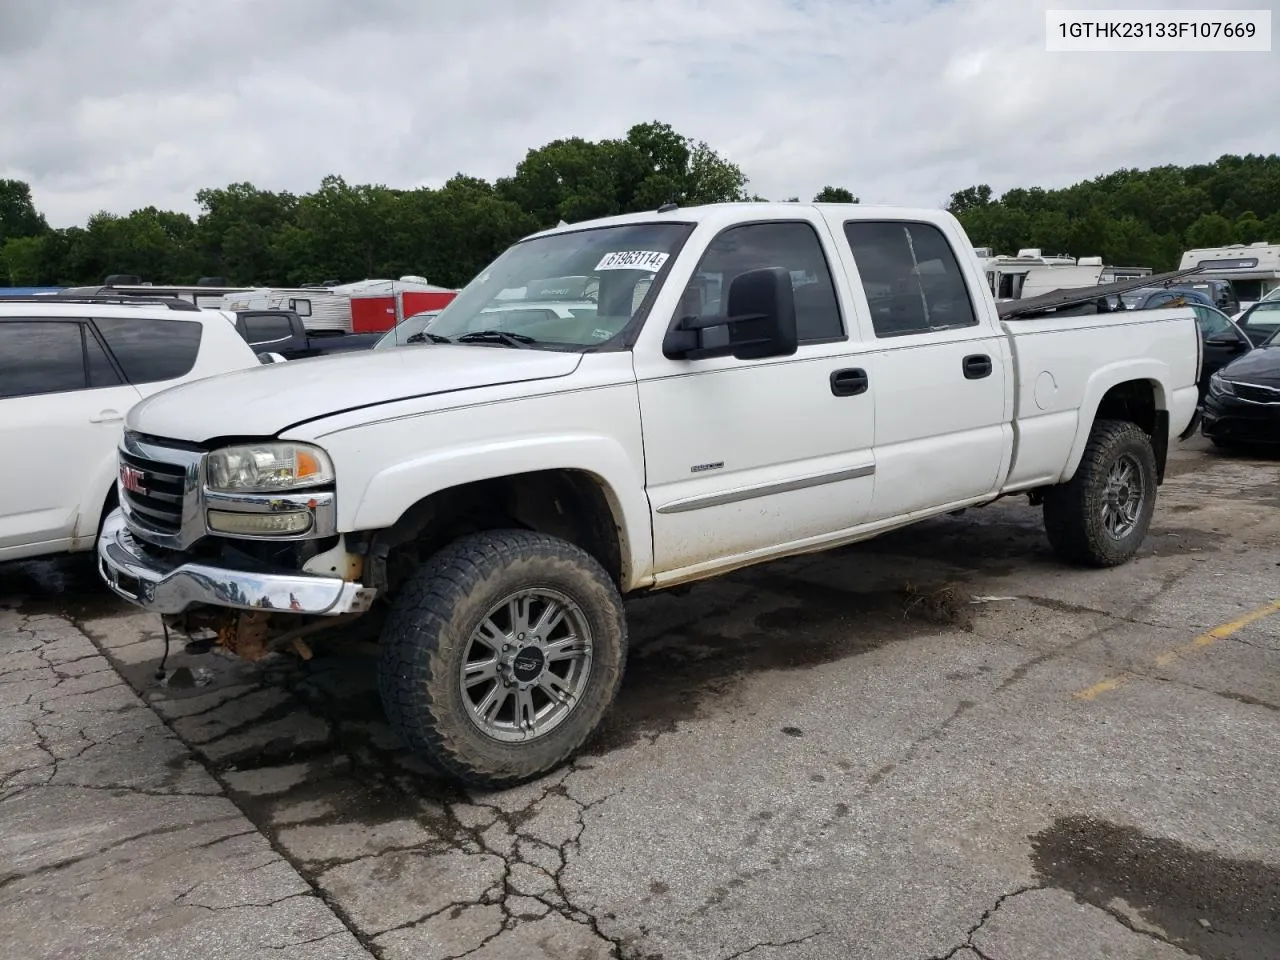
1044 420 1156 567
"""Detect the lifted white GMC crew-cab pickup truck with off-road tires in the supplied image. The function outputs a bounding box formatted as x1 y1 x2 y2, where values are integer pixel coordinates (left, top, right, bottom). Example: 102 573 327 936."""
99 204 1201 787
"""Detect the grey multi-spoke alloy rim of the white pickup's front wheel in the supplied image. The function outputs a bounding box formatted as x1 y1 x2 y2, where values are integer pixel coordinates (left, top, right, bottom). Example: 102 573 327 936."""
458 588 591 742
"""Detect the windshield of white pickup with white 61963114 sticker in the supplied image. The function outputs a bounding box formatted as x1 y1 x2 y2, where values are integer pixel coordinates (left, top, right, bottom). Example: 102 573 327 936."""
428 223 692 351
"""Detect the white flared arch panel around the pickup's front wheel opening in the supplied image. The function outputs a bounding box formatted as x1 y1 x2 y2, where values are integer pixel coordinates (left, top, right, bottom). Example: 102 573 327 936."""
339 434 653 589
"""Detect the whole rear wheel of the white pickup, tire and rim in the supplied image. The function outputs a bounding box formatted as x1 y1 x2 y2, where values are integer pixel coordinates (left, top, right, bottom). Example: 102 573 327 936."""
1044 420 1156 567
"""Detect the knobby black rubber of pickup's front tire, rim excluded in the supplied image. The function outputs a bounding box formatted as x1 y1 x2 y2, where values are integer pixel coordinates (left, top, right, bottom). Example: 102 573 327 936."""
378 530 627 790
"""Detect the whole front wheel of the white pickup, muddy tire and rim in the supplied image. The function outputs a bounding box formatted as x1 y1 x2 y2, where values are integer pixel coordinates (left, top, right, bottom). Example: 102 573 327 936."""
379 530 627 790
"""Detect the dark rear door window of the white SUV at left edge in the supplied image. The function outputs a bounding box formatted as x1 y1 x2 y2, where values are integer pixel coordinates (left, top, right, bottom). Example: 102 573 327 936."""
0 320 87 398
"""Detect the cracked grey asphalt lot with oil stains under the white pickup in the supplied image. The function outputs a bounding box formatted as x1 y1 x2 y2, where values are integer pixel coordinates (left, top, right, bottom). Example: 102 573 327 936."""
0 439 1280 960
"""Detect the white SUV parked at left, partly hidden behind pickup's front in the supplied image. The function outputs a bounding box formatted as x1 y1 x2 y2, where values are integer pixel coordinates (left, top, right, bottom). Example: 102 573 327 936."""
0 296 260 562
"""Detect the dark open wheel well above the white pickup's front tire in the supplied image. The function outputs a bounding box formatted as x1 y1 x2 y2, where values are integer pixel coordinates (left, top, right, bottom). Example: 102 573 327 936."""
367 470 626 593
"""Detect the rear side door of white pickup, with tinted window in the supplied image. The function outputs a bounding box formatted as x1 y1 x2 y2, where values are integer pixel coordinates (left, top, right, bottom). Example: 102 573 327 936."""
829 214 1012 521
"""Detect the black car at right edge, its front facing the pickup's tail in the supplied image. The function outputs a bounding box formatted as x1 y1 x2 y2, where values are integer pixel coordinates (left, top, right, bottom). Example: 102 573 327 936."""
1201 330 1280 447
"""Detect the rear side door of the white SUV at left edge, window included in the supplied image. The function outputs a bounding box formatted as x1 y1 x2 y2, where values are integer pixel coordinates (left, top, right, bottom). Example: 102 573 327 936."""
0 320 141 561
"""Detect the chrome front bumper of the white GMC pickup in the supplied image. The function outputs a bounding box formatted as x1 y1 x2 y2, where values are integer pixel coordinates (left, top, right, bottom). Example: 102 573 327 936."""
97 509 376 617
